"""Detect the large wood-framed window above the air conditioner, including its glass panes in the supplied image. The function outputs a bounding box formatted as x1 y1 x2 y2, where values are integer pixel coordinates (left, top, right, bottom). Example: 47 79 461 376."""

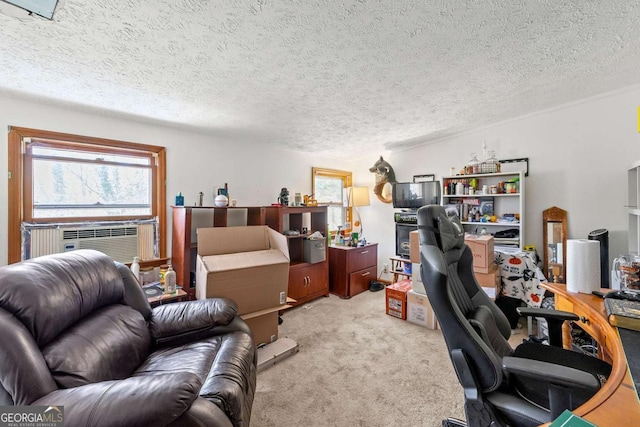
9 127 166 263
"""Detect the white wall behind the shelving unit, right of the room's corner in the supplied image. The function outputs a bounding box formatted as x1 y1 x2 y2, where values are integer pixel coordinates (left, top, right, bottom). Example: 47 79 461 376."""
355 86 640 282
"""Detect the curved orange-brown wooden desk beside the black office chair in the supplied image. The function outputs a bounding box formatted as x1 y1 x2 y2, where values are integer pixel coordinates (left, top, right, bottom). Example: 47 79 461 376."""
542 283 640 427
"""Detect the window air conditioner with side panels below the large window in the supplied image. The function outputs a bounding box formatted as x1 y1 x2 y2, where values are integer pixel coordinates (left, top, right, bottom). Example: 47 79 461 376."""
27 223 157 262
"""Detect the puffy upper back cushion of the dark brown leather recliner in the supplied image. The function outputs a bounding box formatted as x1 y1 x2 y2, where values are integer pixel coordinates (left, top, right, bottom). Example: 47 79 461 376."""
0 249 124 348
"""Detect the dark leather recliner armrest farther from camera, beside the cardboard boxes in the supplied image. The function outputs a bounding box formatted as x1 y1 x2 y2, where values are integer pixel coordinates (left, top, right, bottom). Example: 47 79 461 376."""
149 298 250 345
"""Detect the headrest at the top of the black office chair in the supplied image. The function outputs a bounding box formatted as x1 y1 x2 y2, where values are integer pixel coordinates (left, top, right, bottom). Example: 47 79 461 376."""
418 205 464 252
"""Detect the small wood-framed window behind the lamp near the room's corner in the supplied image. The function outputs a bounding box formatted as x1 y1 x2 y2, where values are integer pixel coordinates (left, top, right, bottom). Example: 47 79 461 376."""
311 168 351 231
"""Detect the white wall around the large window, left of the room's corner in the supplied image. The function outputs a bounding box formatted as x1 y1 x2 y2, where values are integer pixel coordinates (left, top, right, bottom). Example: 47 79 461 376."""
0 97 351 265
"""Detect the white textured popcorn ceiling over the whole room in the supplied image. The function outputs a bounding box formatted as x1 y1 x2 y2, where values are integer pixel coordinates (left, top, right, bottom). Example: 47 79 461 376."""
0 0 640 156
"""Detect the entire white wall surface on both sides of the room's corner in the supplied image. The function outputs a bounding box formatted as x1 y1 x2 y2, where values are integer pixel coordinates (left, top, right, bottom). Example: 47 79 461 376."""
0 87 640 284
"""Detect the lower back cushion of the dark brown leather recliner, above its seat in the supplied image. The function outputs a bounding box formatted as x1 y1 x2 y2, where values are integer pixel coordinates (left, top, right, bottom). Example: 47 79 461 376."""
42 304 151 388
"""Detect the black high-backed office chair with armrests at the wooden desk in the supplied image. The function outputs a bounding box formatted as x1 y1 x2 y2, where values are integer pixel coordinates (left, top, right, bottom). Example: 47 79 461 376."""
418 205 611 427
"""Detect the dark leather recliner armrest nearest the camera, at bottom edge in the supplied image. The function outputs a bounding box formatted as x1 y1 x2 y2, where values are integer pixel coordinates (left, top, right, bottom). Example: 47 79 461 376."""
31 372 202 427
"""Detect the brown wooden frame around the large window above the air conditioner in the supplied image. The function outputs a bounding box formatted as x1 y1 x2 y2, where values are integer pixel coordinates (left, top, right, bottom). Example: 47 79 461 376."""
8 126 167 264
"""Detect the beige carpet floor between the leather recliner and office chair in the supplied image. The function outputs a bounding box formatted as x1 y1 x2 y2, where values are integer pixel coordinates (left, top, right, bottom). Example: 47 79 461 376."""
251 290 464 427
